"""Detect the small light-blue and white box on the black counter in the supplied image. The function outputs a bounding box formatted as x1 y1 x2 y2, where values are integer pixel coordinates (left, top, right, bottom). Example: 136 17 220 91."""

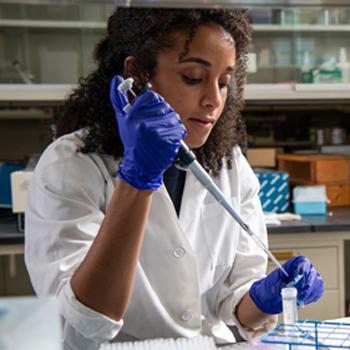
293 185 327 215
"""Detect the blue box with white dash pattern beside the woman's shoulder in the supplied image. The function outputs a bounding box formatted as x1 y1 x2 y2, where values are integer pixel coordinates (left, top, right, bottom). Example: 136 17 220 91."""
256 171 289 213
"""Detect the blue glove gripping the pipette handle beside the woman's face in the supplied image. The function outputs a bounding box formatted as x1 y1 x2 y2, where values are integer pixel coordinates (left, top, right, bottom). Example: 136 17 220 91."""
110 75 186 190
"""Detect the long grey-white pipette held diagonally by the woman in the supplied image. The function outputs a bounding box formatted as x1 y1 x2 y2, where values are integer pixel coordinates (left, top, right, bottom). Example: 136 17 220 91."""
118 78 288 276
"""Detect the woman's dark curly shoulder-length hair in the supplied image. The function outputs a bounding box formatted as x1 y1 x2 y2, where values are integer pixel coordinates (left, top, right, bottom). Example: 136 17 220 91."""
56 8 251 175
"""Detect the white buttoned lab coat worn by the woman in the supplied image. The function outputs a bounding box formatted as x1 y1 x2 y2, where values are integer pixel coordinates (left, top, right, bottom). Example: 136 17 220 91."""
25 131 276 350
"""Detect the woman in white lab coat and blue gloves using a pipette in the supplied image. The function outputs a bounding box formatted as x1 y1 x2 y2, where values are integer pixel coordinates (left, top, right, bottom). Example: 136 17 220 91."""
25 8 323 350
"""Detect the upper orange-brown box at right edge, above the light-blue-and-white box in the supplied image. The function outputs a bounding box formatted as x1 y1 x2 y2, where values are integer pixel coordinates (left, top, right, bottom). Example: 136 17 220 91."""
277 154 350 185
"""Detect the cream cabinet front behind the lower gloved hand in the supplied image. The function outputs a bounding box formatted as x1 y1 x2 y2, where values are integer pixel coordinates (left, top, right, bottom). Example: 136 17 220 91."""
269 232 345 320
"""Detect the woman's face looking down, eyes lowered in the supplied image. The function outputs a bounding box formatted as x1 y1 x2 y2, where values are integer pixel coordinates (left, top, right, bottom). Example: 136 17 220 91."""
150 24 236 148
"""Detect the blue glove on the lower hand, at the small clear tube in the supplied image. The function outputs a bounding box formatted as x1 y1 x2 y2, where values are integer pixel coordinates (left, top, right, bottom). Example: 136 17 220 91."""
249 256 323 314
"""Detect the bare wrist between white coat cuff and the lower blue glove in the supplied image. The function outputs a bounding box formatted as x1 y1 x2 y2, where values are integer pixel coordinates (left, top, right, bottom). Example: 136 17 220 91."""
236 293 277 330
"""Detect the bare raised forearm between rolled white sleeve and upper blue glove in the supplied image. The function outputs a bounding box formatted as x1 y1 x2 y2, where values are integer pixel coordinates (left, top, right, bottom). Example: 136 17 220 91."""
71 181 152 320
